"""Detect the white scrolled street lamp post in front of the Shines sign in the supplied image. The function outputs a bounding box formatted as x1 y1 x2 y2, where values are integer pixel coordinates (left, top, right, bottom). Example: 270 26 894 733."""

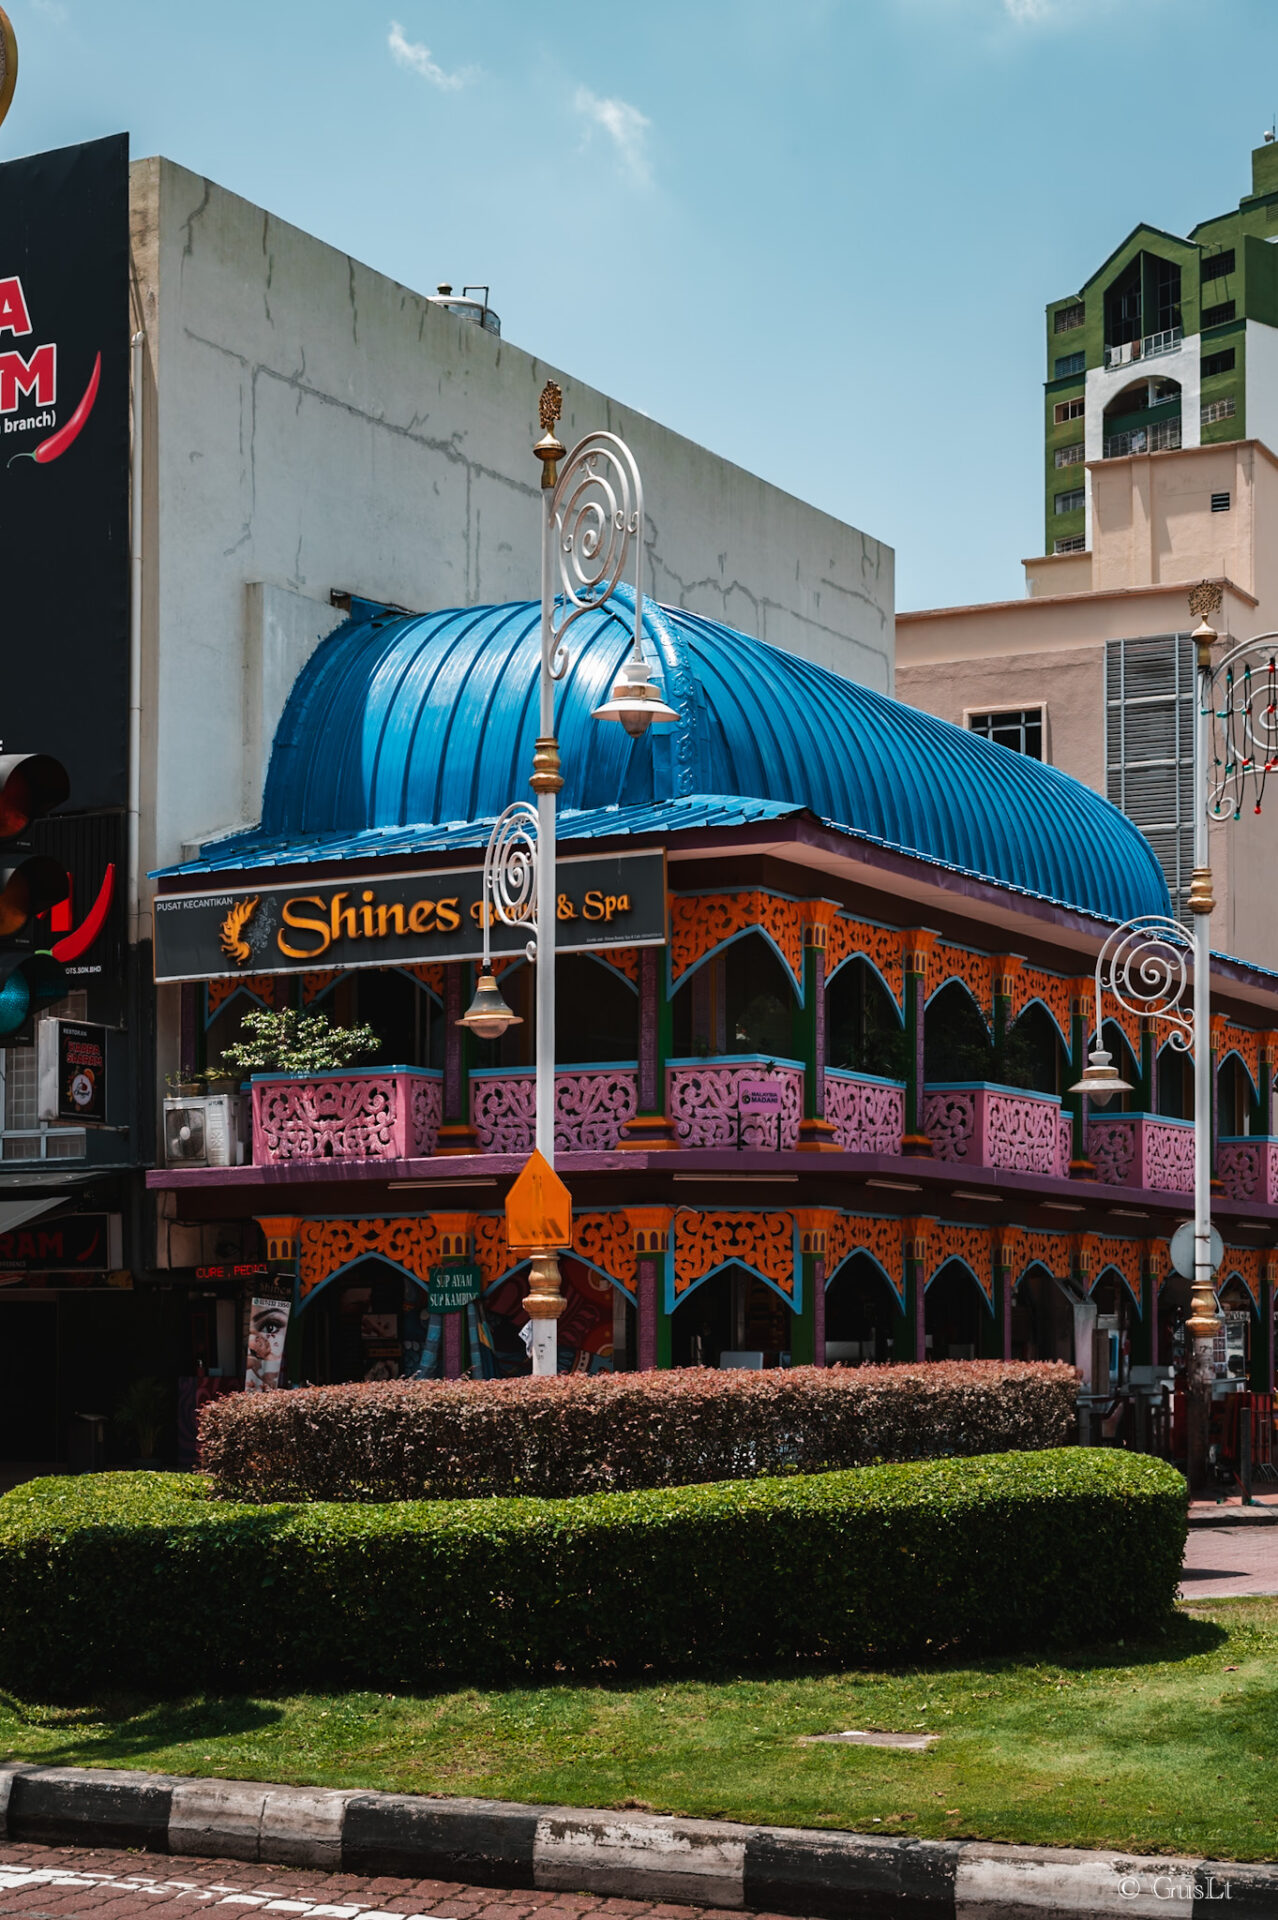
462 380 679 1375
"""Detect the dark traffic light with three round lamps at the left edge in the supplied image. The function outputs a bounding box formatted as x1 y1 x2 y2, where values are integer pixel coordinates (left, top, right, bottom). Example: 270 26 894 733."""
0 753 71 1046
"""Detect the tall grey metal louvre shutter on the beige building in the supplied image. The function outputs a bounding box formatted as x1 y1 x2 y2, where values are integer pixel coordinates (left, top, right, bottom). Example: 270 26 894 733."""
1105 634 1194 914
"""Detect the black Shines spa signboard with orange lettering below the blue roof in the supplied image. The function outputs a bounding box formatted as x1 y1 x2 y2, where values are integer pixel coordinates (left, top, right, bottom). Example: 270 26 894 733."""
154 852 666 981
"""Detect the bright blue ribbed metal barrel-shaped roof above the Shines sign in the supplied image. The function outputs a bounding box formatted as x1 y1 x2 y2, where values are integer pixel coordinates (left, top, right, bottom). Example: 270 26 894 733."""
251 593 1171 920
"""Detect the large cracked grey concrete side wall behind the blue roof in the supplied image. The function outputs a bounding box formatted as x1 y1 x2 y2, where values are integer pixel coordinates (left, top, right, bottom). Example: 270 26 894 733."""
132 159 892 868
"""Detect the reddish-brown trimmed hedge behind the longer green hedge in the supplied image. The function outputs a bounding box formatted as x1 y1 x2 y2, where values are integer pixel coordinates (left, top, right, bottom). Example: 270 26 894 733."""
200 1359 1078 1500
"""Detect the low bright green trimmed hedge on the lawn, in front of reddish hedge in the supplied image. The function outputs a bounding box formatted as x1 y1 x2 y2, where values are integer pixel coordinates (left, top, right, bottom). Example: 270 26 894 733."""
0 1448 1186 1695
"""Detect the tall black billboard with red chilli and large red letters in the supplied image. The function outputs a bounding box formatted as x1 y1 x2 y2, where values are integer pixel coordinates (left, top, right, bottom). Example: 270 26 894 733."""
0 134 130 812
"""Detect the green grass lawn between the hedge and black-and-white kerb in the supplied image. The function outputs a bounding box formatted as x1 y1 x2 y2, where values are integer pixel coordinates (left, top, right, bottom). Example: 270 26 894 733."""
0 1599 1278 1860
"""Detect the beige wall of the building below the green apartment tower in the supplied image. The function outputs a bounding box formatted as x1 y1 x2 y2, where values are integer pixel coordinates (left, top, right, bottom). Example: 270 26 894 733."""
896 440 1278 968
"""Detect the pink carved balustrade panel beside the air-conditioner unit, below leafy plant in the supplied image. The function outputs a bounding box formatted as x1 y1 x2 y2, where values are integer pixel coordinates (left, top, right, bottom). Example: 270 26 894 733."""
253 1068 443 1167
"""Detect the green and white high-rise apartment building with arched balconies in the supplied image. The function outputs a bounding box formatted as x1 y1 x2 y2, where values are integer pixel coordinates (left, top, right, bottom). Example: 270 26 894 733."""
1044 134 1278 553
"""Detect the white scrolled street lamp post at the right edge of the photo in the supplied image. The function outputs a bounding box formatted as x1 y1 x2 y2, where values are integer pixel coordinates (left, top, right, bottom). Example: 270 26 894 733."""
1071 580 1278 1492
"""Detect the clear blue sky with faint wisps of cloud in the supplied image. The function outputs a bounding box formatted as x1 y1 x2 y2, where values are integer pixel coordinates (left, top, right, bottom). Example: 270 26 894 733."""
0 0 1278 609
